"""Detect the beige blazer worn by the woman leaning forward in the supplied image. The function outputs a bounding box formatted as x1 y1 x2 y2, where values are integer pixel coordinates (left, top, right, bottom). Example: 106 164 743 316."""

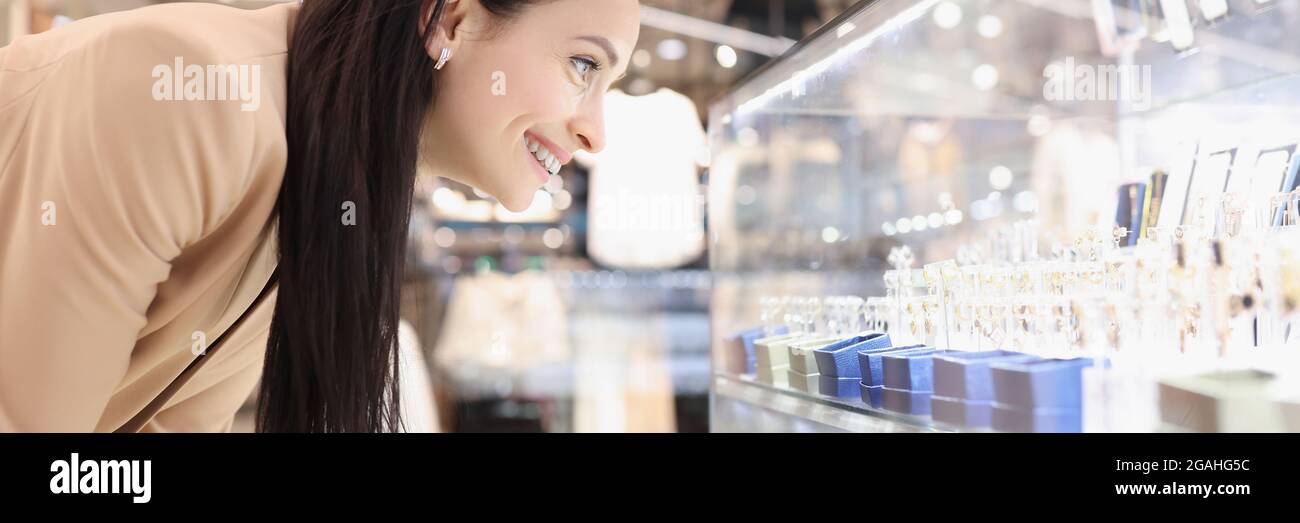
0 4 296 432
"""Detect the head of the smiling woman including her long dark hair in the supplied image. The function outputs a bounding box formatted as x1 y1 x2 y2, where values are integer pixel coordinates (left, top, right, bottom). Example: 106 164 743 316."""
267 0 640 431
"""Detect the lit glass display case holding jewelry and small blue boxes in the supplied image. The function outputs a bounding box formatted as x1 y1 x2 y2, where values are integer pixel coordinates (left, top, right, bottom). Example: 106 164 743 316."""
709 0 1300 432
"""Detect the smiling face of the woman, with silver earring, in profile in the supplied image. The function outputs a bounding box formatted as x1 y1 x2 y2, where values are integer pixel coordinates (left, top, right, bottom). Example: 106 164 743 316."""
424 0 641 211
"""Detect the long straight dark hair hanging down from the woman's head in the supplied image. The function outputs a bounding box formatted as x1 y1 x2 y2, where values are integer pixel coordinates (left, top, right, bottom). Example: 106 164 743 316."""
257 0 537 432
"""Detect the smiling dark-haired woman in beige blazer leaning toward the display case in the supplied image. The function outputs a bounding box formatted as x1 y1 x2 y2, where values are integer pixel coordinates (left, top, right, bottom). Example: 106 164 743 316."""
0 0 640 432
